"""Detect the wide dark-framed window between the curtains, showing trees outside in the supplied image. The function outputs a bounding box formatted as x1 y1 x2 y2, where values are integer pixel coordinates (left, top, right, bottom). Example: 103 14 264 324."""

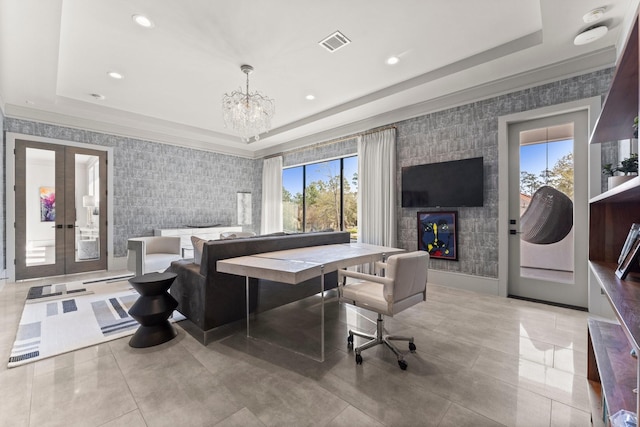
282 156 358 240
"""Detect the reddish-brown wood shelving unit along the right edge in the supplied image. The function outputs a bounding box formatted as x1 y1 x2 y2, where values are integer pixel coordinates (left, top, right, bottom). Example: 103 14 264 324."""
587 12 640 425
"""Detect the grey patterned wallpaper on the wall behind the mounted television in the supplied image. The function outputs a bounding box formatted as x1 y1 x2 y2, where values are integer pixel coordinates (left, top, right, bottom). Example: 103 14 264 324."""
396 69 613 278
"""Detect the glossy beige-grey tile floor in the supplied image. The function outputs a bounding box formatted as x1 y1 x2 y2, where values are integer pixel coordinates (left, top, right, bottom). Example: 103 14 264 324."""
0 272 590 427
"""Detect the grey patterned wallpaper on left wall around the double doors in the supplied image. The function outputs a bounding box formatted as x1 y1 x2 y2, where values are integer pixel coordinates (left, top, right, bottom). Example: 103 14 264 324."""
5 121 262 257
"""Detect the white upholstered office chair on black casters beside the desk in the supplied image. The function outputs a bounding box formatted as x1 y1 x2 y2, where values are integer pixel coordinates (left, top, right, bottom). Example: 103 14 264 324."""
338 251 429 370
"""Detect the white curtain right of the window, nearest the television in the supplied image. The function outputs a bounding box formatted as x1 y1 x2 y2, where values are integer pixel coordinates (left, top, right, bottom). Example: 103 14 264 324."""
358 128 397 247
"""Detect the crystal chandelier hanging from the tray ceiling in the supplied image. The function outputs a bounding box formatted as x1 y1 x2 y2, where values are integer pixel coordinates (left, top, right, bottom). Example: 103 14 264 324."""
222 65 275 143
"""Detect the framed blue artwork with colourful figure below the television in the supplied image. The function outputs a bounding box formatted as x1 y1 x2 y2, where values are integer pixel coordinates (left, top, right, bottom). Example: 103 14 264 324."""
418 211 458 261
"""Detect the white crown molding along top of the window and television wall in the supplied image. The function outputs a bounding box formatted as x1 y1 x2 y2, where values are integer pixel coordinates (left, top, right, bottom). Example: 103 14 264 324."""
255 47 616 157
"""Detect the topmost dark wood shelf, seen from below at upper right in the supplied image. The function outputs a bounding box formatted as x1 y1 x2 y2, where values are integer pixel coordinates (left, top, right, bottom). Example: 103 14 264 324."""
589 18 638 144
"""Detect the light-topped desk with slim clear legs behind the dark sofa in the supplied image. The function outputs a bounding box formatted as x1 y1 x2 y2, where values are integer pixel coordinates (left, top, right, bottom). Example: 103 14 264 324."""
217 243 404 362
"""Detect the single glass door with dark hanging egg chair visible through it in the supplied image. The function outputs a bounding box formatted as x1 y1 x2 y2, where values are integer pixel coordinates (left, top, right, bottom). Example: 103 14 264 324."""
508 111 588 308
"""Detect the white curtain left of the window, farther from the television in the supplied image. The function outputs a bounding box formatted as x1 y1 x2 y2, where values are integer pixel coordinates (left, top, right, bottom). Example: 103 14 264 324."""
261 156 282 234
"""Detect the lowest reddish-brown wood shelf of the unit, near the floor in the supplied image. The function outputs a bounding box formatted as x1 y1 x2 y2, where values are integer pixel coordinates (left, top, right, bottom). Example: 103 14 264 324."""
588 319 636 425
